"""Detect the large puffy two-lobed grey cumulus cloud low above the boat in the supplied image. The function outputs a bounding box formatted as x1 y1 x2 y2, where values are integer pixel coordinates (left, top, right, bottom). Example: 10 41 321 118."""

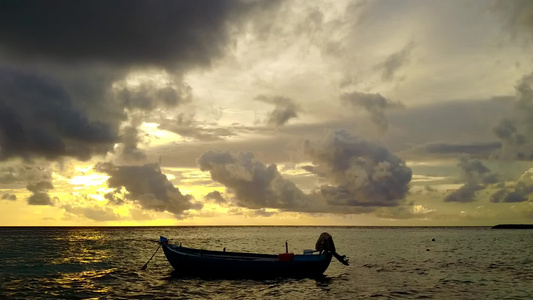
198 130 411 213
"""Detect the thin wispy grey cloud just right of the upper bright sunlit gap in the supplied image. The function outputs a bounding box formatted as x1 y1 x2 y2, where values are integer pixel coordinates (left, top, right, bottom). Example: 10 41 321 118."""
158 113 236 142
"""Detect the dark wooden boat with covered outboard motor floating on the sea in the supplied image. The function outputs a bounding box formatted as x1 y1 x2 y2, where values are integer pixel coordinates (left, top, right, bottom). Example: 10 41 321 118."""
160 233 348 278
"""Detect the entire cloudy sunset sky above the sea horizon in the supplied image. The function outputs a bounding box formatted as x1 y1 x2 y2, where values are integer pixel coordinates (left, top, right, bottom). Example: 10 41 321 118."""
0 0 533 226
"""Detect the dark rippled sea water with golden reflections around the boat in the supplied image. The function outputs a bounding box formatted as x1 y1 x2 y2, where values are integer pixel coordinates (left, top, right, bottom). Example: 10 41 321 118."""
0 227 533 299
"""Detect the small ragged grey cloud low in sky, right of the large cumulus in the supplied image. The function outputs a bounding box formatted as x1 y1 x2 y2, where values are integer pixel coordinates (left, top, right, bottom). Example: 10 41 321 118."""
444 154 499 203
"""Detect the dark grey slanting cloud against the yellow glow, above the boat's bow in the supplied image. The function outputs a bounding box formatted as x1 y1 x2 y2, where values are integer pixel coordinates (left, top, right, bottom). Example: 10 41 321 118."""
94 163 202 216
